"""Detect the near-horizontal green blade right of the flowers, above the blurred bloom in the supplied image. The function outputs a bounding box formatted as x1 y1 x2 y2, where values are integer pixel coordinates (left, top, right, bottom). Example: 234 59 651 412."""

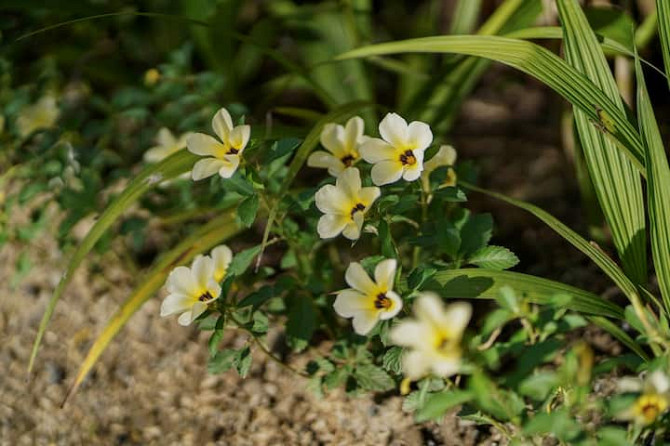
426 268 623 319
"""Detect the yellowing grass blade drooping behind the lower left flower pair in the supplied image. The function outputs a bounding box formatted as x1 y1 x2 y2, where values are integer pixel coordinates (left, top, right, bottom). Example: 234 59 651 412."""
63 210 240 404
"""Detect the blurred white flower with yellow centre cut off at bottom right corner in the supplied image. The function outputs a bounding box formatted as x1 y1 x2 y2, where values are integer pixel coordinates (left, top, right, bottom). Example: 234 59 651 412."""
618 370 670 426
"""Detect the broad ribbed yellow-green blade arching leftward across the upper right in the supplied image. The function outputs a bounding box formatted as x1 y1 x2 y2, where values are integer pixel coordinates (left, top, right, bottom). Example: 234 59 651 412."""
338 36 646 175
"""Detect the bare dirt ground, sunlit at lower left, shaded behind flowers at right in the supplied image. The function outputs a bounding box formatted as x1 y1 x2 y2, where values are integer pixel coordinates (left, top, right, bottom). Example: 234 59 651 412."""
0 68 620 446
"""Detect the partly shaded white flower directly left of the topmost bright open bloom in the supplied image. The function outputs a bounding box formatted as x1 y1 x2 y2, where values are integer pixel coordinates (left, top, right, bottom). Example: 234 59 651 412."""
307 116 369 177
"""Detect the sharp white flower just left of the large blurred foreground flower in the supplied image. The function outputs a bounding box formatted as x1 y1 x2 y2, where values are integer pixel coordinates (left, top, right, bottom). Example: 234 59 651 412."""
333 259 402 335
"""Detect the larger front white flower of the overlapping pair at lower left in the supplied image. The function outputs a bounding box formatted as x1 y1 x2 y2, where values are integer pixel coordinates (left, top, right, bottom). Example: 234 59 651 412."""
161 256 221 325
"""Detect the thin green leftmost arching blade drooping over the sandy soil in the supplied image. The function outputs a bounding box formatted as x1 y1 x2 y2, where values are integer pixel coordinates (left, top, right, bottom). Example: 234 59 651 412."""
28 150 198 373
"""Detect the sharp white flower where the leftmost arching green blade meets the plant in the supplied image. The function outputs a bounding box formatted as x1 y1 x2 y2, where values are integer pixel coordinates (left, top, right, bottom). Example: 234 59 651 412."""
186 108 251 181
